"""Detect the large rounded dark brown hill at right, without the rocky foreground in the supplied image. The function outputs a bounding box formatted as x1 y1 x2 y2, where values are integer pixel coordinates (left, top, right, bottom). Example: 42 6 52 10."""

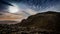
19 11 60 31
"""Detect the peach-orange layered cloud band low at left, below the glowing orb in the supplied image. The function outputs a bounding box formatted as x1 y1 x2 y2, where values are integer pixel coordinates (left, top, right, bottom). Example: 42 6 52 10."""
0 12 24 21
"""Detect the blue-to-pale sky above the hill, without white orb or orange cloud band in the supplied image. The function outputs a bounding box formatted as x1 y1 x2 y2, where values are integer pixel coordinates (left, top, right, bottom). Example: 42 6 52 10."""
0 0 60 20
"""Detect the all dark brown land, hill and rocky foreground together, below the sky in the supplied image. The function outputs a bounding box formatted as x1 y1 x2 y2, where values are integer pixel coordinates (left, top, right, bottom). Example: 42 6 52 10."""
0 11 60 34
